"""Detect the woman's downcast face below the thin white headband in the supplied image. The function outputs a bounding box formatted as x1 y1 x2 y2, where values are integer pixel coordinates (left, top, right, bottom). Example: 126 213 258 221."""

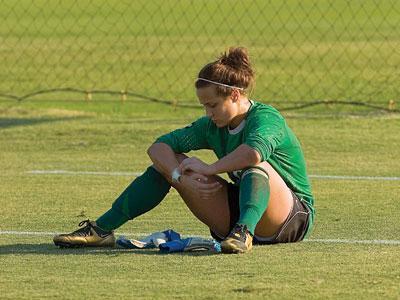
196 85 240 127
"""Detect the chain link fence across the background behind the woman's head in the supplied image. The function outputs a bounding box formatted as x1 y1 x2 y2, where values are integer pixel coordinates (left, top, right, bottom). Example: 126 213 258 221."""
0 0 400 109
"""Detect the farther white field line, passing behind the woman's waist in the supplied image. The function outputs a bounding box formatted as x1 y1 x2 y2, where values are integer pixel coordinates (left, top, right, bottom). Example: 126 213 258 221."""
26 170 400 181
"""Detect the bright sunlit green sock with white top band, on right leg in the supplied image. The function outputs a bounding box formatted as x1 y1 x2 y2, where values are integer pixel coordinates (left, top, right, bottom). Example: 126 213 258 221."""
238 168 269 235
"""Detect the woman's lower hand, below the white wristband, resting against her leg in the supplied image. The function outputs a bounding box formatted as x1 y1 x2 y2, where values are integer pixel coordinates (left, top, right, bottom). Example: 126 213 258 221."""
180 172 222 200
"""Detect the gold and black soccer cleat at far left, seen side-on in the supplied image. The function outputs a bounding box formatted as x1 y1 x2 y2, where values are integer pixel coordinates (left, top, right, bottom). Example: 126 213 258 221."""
53 220 115 248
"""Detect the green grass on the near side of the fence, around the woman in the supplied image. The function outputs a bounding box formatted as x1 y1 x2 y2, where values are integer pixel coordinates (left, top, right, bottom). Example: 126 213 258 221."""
0 101 400 299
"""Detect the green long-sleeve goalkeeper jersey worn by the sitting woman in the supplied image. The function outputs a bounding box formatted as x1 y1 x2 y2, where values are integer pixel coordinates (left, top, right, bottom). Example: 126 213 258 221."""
156 101 315 234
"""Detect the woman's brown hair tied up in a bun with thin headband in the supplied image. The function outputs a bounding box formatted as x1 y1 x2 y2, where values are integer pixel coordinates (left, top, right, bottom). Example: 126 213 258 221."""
195 47 254 97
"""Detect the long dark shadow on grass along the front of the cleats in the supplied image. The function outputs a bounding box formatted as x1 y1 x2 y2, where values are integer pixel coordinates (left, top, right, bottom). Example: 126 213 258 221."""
0 243 220 257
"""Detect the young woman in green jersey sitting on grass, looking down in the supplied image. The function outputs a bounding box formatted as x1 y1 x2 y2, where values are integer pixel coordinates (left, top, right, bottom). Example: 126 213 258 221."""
54 48 314 253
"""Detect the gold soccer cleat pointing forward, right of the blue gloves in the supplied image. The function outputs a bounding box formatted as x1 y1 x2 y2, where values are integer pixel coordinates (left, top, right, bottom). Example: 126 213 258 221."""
221 224 253 253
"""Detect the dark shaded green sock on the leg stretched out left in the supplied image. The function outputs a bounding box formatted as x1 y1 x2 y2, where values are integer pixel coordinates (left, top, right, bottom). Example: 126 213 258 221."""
96 167 171 231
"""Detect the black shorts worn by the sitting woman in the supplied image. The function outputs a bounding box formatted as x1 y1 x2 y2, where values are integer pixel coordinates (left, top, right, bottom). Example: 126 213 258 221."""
210 183 310 245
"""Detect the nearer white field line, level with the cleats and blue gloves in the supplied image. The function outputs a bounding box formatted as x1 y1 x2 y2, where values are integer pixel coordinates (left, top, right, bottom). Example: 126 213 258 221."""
0 230 400 245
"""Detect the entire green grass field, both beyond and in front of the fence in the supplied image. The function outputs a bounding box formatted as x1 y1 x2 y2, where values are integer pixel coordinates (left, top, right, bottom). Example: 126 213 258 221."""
0 0 400 299
